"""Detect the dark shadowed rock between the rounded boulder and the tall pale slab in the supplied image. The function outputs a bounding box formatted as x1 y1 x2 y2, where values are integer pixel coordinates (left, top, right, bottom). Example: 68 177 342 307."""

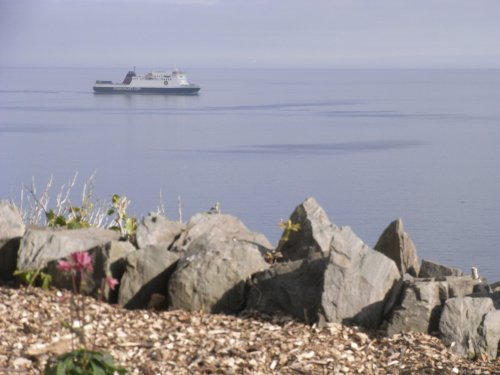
245 258 328 324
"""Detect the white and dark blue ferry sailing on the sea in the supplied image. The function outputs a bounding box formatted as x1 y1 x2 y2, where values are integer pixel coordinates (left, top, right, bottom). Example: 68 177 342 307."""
93 68 200 94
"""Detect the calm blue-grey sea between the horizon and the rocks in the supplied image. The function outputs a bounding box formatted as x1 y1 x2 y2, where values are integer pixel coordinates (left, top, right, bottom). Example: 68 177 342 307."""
0 67 500 282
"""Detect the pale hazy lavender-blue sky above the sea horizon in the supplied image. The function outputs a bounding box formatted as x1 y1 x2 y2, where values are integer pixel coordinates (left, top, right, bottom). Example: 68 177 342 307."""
0 0 500 68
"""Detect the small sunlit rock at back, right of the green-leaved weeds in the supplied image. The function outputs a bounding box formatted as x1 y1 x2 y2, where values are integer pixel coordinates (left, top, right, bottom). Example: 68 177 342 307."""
136 213 186 249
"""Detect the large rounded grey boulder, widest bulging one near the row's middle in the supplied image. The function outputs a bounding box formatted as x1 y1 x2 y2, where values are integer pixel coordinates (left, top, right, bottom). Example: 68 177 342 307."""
168 233 269 313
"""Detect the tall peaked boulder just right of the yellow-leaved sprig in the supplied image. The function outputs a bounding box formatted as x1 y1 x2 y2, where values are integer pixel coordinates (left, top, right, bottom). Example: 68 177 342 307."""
278 198 338 261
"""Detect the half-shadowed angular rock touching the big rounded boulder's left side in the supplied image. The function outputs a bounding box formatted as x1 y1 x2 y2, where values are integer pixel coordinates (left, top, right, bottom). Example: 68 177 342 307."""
118 246 179 309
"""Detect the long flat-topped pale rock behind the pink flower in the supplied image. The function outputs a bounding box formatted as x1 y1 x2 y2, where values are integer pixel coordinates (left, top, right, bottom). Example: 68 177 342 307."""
17 228 120 270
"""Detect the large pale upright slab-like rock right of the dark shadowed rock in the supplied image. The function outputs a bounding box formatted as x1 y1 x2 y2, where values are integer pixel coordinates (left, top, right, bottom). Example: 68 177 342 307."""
320 227 400 328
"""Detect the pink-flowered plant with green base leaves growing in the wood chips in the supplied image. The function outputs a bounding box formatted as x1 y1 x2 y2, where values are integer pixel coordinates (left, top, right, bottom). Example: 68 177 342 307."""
44 251 128 375
